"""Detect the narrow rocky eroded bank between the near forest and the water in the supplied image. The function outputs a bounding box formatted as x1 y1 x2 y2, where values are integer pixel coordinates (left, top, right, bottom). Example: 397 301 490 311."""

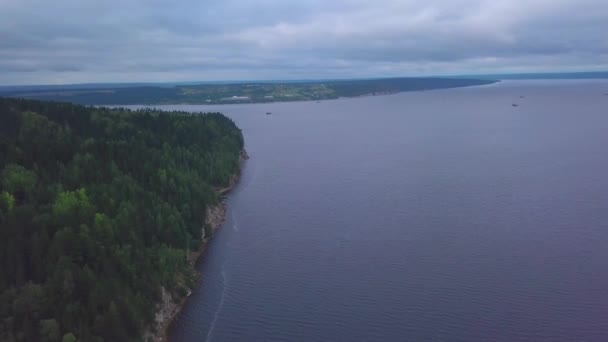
143 149 249 342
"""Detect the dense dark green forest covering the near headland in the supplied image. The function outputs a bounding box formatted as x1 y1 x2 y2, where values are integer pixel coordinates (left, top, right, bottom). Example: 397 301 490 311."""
0 98 244 342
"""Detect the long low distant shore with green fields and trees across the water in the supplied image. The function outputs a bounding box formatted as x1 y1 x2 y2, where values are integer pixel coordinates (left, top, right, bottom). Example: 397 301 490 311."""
0 78 495 105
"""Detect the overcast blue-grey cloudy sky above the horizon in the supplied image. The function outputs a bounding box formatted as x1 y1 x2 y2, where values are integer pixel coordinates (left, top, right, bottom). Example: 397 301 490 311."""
0 0 608 85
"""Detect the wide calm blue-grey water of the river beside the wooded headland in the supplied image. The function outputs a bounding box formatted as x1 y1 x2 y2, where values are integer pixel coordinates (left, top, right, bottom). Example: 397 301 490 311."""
158 81 608 341
